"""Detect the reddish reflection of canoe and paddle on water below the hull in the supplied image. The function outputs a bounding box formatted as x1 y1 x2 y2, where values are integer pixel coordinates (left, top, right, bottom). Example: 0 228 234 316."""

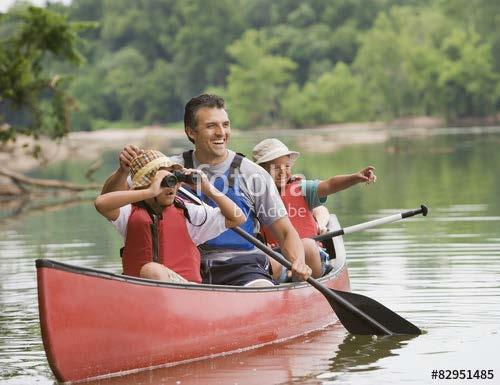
82 325 415 385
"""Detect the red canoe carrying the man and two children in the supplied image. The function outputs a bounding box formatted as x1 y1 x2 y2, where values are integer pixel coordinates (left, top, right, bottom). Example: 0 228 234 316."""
36 216 350 382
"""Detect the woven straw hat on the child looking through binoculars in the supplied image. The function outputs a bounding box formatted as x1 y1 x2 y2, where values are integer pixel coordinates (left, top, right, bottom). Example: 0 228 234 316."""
130 150 183 189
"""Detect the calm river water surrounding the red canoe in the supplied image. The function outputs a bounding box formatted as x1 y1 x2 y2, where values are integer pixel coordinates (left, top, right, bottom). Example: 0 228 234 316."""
0 129 500 385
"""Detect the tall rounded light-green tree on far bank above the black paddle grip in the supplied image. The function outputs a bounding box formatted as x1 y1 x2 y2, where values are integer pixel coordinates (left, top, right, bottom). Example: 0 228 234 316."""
354 7 446 118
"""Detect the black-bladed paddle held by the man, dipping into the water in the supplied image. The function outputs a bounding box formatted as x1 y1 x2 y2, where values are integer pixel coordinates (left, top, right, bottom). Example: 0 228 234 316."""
179 187 422 335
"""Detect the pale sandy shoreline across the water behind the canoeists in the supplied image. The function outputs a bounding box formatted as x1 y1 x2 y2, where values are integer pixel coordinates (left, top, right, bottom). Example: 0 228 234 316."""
0 117 500 174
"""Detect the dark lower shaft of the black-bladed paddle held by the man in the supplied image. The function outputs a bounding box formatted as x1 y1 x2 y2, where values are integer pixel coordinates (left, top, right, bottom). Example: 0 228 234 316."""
231 227 394 335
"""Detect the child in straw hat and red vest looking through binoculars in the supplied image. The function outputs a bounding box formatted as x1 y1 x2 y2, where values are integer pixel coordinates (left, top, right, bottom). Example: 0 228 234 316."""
95 150 246 283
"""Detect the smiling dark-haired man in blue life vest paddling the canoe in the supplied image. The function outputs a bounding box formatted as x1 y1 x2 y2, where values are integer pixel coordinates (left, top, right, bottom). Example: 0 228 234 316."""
103 94 311 286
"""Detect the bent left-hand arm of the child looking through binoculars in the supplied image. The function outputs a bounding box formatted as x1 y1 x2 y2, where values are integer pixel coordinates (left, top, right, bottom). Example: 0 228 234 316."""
94 170 168 221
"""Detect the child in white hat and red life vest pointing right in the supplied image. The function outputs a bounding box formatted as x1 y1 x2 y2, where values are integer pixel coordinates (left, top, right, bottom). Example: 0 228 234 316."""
252 138 377 282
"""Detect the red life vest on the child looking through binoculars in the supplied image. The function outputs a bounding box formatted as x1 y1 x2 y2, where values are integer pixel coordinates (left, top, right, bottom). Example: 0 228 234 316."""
122 201 201 283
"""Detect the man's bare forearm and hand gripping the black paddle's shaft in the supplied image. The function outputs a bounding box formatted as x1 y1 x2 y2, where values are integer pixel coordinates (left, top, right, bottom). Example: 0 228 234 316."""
270 217 311 281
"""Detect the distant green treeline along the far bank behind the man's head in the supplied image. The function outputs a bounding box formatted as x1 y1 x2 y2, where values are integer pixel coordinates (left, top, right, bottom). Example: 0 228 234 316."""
12 0 500 130
